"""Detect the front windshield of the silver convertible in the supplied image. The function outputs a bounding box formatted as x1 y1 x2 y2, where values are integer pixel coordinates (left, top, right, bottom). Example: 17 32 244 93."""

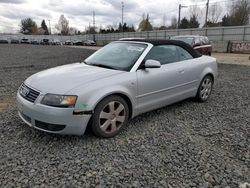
85 42 147 71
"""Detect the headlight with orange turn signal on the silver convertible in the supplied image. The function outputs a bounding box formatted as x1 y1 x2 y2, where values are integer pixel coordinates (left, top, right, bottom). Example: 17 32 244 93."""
41 94 77 108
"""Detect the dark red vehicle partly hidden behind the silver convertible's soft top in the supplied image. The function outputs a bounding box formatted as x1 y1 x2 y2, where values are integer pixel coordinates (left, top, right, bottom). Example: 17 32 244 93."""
171 35 212 56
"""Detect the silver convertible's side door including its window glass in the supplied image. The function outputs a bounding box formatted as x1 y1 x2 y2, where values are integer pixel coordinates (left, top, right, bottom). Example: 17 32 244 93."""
136 45 198 113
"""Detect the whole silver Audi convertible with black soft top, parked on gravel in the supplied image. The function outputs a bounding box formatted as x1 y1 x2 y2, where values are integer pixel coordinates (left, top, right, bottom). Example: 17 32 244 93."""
17 39 217 138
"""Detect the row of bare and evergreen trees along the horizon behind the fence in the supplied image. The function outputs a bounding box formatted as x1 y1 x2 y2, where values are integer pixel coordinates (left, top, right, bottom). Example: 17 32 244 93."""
20 0 250 35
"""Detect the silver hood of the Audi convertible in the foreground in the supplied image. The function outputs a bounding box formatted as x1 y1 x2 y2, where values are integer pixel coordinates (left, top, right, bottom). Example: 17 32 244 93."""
25 63 122 94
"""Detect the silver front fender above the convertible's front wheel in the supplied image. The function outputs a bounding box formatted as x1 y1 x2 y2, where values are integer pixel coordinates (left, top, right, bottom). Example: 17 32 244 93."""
68 73 137 116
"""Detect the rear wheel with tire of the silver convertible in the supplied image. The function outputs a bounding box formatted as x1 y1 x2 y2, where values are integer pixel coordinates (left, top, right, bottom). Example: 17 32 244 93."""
195 75 213 102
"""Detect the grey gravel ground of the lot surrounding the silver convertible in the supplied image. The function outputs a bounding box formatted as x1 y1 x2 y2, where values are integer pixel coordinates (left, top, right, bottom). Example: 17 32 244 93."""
0 45 250 188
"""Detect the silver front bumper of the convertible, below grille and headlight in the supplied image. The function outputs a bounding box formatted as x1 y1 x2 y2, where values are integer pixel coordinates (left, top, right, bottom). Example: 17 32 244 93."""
17 92 91 135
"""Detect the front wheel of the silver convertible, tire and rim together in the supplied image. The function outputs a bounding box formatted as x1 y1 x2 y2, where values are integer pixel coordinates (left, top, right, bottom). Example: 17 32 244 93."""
91 95 129 138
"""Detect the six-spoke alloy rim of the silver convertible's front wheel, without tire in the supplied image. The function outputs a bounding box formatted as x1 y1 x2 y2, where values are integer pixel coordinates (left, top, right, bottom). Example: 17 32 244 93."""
99 101 126 134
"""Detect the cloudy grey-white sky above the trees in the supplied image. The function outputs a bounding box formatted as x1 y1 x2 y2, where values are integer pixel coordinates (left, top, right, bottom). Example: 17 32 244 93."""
0 0 229 33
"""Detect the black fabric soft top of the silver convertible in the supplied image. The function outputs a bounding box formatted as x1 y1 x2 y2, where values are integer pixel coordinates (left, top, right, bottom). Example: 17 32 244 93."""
120 39 202 58
